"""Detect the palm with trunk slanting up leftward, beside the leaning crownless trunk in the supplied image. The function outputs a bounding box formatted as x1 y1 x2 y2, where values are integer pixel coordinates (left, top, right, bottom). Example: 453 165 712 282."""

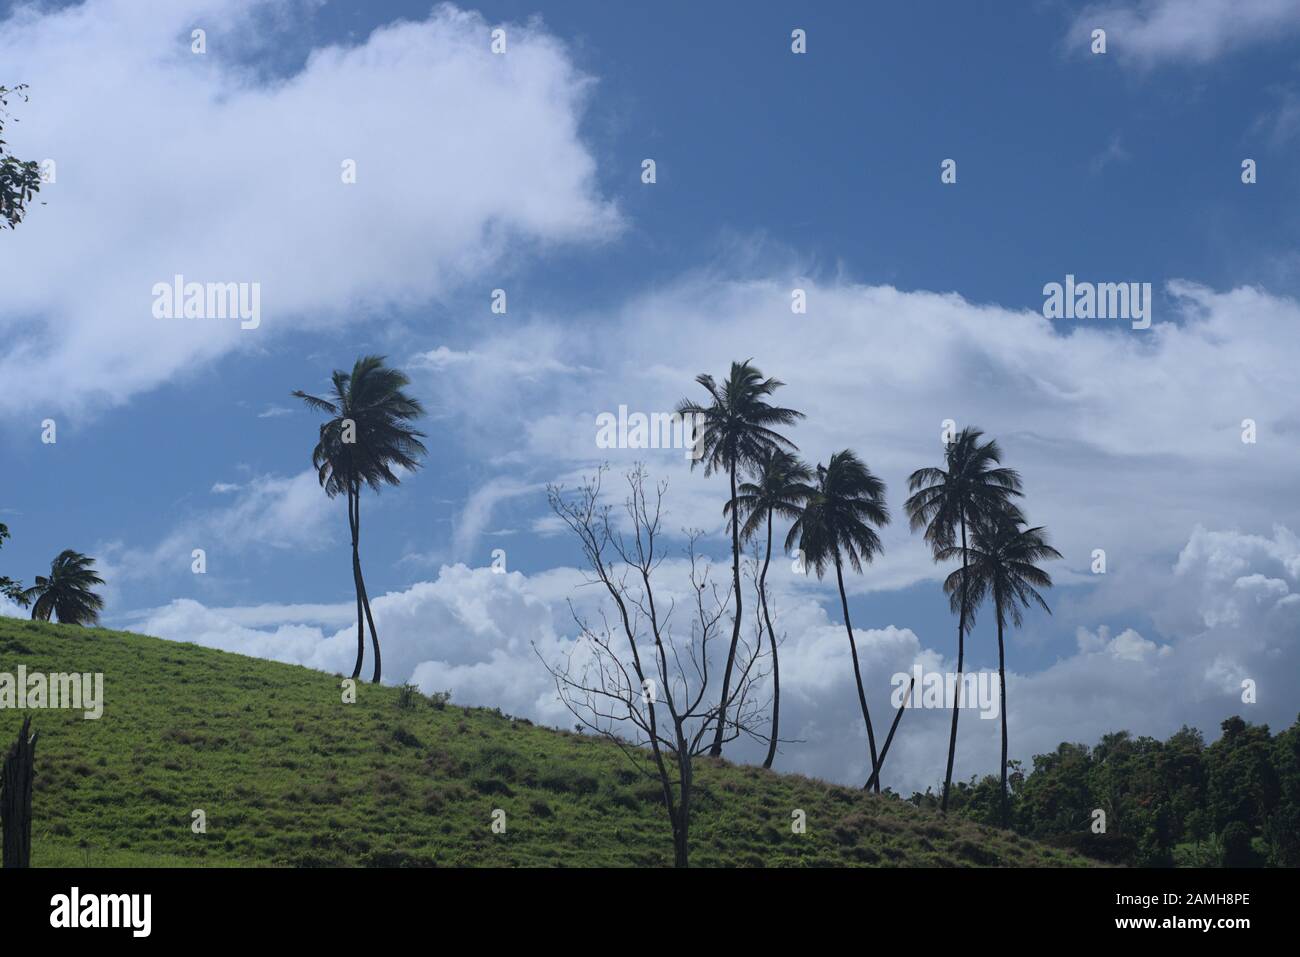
785 449 889 792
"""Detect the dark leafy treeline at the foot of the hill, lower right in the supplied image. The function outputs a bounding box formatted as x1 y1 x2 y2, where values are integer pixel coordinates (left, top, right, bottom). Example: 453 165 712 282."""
910 716 1300 867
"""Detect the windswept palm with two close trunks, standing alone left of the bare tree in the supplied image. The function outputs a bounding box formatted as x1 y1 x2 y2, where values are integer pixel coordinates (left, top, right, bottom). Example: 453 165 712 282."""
293 355 428 684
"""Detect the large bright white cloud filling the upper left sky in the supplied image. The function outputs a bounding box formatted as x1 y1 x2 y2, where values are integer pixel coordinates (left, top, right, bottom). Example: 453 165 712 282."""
0 0 620 411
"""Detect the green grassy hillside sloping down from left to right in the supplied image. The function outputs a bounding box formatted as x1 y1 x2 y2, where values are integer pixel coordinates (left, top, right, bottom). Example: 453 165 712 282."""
0 619 1088 866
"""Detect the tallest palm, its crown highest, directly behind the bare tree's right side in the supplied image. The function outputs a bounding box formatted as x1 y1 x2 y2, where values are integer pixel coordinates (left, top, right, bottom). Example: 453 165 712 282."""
677 359 803 758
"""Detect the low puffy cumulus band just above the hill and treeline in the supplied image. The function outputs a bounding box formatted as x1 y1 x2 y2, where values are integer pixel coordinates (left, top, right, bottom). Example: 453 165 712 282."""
126 528 1300 793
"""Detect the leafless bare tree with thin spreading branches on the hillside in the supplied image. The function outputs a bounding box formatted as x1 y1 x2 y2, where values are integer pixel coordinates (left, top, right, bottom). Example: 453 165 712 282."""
534 465 766 867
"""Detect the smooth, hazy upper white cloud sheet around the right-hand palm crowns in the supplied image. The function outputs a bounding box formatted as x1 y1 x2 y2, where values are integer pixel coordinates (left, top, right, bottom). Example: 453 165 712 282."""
425 270 1300 607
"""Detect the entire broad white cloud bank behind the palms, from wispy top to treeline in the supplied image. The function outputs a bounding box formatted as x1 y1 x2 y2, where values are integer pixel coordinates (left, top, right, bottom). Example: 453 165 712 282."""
78 250 1300 791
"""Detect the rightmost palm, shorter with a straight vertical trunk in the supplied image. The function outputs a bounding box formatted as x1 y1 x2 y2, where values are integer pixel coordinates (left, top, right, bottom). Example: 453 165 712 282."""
939 514 1062 827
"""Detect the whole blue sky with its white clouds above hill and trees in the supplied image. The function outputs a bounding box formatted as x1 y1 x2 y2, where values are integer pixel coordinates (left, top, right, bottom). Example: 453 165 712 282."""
0 0 1300 787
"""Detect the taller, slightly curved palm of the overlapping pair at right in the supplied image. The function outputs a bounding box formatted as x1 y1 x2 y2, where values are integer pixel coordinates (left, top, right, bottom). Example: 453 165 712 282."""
905 428 1021 811
